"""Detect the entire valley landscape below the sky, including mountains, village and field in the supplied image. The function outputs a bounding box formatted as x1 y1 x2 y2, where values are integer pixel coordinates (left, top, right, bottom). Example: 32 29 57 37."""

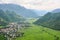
0 4 60 40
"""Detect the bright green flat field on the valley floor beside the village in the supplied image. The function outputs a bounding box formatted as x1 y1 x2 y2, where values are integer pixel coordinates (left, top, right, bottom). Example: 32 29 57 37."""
16 25 60 40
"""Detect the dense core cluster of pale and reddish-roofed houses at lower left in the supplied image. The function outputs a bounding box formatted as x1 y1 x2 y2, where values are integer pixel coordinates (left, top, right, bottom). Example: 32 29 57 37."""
0 23 24 40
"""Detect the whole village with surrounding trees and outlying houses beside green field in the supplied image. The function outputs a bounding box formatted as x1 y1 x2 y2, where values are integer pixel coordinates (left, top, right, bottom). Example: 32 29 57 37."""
0 22 29 40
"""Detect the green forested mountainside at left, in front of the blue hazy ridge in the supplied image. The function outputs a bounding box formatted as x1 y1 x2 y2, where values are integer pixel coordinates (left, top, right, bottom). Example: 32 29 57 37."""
0 9 24 26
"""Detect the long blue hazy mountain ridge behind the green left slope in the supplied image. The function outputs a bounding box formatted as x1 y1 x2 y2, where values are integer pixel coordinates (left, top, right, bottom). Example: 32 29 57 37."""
0 4 38 18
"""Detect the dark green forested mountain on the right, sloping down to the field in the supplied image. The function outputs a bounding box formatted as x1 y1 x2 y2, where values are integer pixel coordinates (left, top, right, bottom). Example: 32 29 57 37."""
34 12 60 30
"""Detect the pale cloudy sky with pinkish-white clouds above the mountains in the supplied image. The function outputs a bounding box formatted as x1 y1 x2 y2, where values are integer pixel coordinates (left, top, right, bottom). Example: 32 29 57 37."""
0 0 60 10
